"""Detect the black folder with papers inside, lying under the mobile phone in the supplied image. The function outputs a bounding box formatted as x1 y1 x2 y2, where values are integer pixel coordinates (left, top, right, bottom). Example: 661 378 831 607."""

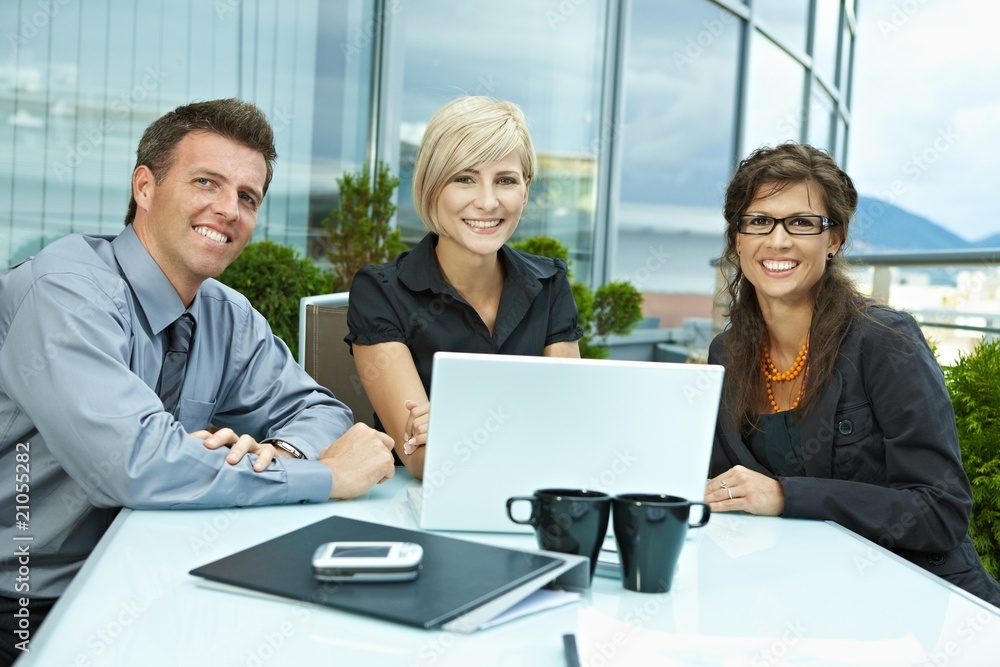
191 517 589 632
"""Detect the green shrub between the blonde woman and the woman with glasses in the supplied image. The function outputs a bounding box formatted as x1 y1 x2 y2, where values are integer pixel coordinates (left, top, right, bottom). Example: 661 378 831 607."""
511 236 642 359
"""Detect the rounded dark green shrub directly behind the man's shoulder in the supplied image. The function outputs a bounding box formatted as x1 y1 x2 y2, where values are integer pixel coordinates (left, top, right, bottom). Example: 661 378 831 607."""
219 241 332 357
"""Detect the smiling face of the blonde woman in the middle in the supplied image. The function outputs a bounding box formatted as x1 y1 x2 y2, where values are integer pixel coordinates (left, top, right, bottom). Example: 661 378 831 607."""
435 151 529 255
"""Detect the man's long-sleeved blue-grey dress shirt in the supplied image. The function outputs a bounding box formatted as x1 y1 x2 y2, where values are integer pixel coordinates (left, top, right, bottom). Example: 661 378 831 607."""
0 227 353 597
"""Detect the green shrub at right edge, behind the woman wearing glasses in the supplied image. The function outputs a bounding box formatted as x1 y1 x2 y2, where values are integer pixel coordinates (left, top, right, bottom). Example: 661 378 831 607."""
945 339 1000 579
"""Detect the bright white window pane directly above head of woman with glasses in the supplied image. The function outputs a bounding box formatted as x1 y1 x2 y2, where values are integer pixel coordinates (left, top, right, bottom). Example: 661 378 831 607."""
743 32 805 155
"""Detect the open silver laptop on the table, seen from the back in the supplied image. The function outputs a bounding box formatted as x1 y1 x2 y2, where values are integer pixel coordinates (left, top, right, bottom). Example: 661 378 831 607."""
413 352 723 533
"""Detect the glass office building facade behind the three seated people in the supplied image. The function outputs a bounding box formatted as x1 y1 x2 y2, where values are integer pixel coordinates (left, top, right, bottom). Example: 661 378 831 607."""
0 0 855 324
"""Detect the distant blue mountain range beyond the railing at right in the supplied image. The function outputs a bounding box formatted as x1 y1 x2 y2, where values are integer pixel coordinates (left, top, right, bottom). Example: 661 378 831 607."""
850 195 1000 253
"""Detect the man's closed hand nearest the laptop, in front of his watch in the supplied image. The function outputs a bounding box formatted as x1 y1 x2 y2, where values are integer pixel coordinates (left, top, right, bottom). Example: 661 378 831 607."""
319 424 396 500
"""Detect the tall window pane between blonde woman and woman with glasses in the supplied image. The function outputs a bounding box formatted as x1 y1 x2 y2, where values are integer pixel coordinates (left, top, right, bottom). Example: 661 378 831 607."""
613 0 742 326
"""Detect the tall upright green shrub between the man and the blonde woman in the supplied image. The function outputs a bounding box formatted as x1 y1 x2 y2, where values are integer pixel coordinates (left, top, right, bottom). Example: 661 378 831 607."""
323 162 406 292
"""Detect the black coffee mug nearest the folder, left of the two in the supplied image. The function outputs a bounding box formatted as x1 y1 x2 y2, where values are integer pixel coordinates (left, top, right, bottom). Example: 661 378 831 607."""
507 489 611 580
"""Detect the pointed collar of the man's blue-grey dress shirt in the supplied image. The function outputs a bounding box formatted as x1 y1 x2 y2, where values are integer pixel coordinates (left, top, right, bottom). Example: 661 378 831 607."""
111 225 201 333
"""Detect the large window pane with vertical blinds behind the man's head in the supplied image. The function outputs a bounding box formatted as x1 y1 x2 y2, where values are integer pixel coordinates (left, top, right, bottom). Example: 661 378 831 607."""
0 0 373 266
